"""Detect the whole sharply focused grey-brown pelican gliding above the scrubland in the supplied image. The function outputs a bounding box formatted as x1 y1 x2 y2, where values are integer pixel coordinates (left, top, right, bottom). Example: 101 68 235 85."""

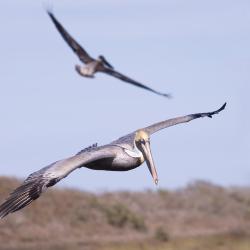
0 103 226 218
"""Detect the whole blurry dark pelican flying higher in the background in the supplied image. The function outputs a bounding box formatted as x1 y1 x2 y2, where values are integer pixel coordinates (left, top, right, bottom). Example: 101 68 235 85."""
47 10 171 98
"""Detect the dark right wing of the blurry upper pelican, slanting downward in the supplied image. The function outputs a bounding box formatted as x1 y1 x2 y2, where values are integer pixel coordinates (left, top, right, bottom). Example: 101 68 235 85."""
98 65 171 98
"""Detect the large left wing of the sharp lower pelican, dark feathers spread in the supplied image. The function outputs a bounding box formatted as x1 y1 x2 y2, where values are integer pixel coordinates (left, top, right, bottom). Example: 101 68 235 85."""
0 146 115 218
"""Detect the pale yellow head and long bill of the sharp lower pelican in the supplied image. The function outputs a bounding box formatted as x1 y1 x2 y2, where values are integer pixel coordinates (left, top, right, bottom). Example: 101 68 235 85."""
135 130 158 184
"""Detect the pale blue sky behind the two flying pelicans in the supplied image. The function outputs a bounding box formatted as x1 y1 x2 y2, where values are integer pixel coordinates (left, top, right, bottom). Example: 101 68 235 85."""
0 0 250 191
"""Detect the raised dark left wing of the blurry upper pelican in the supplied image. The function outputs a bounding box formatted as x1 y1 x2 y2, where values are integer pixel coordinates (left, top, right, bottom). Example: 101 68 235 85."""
47 10 94 63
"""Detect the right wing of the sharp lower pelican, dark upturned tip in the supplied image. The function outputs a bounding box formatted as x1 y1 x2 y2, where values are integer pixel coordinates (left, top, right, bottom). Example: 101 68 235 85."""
142 102 227 135
